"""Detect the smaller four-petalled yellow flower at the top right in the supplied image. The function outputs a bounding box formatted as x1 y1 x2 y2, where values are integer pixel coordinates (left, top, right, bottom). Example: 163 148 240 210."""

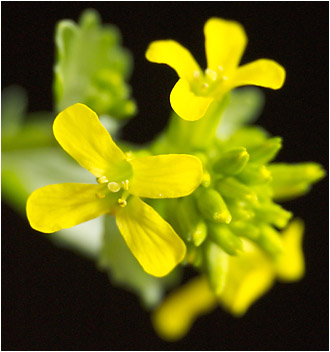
146 18 285 121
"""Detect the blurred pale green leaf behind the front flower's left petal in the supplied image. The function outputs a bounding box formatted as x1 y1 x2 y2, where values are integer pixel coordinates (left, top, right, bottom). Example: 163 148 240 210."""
1 147 102 258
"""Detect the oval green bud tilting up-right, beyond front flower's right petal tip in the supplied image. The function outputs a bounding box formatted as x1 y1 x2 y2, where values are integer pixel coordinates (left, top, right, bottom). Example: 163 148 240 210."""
213 147 249 175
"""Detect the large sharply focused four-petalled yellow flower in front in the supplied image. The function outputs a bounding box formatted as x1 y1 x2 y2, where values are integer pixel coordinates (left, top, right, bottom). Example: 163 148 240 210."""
26 104 203 276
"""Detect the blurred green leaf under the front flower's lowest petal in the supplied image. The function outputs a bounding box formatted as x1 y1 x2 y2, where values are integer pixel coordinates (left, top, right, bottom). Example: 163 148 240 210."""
99 216 180 307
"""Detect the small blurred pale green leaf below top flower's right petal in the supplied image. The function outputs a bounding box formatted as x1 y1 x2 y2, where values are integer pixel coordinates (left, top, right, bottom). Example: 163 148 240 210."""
217 87 265 139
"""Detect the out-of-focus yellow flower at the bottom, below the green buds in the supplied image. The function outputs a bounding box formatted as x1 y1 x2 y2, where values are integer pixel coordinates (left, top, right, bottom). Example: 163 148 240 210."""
152 220 304 341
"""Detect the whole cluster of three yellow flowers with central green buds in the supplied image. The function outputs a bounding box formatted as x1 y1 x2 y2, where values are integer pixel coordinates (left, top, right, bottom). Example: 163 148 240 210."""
27 18 324 340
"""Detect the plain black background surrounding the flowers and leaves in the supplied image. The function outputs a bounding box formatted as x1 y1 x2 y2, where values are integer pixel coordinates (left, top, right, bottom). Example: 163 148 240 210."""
1 2 329 350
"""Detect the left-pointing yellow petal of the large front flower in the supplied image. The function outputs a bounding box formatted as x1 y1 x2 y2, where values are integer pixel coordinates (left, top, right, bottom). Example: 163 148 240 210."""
26 183 116 233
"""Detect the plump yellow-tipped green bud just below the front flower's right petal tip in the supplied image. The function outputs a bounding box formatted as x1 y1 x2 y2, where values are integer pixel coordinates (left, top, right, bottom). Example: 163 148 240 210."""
197 188 231 224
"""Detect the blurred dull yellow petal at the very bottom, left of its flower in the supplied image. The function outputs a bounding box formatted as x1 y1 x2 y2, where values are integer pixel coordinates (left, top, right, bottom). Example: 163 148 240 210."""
152 276 217 341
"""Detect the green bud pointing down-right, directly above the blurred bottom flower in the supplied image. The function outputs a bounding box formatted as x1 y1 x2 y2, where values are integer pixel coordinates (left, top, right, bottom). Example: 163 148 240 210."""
208 224 243 255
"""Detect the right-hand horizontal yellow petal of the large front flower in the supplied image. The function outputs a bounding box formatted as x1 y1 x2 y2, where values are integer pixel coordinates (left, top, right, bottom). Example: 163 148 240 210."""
129 154 203 198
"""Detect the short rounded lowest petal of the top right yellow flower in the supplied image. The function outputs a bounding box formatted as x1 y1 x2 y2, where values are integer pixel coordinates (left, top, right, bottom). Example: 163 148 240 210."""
170 79 213 121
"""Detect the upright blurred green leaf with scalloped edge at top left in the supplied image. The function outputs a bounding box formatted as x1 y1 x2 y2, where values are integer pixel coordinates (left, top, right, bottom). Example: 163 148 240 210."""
54 10 136 119
